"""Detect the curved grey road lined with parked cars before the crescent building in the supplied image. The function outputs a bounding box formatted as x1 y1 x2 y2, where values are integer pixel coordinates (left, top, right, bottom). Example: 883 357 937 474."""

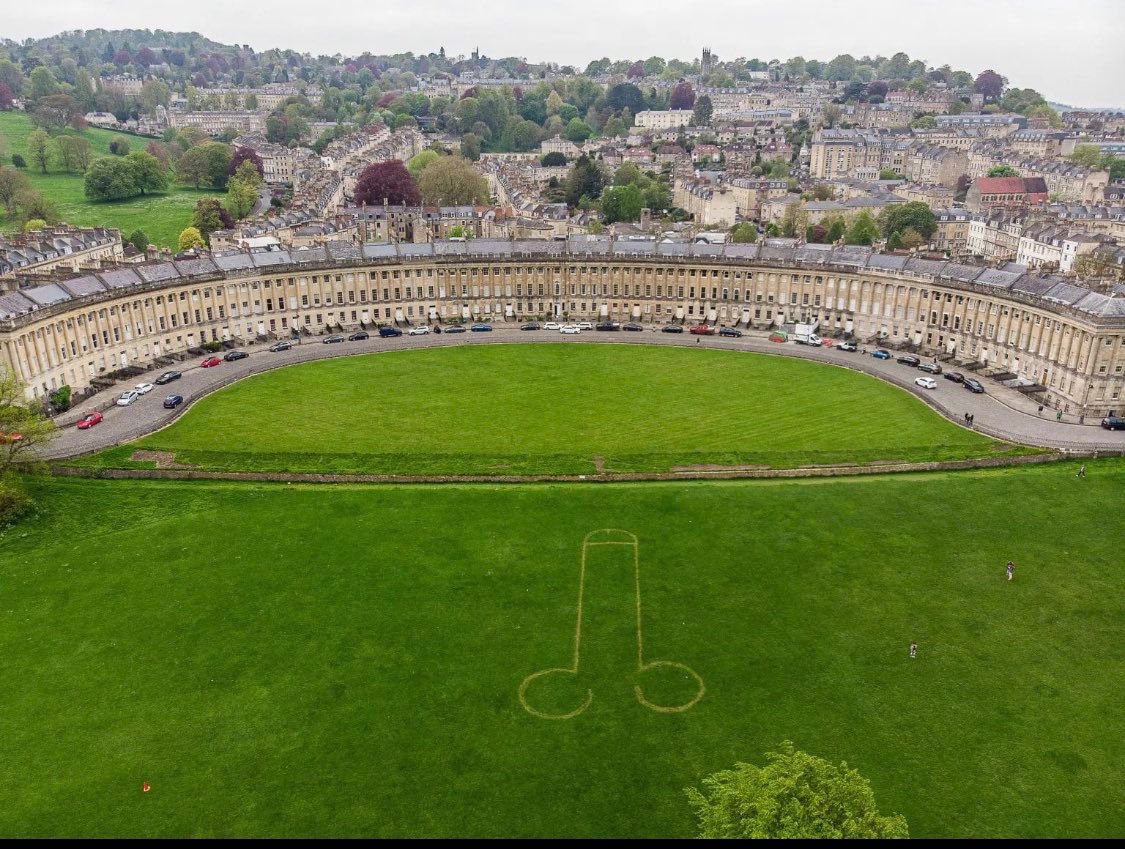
42 326 1125 460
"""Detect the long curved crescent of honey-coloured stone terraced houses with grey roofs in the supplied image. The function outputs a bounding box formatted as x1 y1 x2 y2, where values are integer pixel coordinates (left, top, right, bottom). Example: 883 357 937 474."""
0 237 1125 415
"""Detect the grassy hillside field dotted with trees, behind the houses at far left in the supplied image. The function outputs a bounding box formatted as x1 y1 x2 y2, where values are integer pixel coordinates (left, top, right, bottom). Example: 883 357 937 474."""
0 112 223 249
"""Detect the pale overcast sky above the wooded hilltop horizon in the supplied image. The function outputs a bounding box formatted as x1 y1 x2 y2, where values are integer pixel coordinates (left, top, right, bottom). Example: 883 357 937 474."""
8 0 1125 107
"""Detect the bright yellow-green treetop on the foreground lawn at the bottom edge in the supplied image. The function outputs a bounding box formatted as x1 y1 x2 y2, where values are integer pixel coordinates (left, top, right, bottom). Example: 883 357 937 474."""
686 742 909 839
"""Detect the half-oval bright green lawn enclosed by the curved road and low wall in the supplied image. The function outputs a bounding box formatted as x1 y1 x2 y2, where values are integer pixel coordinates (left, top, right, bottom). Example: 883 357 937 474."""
90 344 1011 475
